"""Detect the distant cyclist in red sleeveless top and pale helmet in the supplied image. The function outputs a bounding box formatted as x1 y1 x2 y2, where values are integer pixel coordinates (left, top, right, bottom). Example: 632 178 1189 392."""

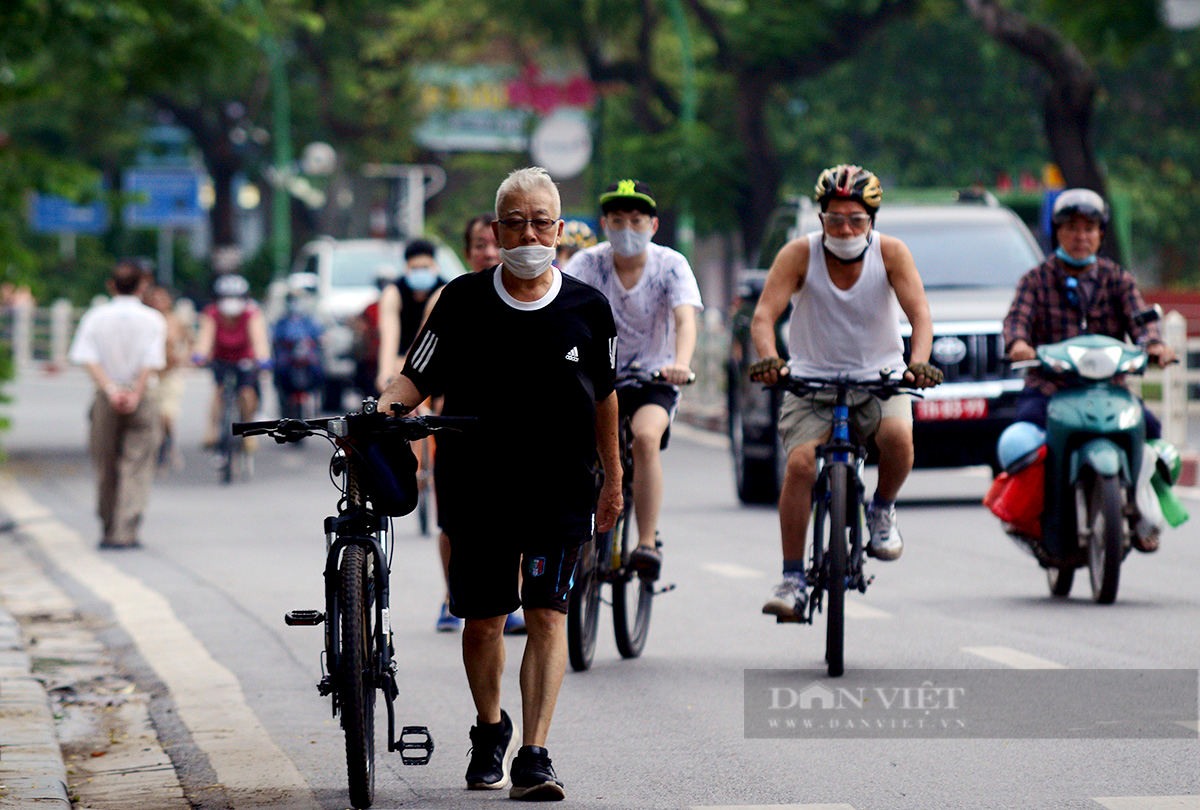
192 274 271 451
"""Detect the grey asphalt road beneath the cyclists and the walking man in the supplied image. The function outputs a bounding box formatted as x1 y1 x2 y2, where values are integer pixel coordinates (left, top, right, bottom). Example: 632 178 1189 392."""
5 371 1200 810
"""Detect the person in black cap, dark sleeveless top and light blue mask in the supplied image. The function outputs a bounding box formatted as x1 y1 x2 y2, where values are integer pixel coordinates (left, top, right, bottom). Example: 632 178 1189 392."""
376 239 445 391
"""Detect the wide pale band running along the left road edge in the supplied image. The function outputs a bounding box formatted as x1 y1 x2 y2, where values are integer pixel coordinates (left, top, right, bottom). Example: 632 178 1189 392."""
0 475 318 810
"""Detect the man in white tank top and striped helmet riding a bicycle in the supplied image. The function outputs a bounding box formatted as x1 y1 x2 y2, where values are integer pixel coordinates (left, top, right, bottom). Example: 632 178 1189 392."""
750 164 942 620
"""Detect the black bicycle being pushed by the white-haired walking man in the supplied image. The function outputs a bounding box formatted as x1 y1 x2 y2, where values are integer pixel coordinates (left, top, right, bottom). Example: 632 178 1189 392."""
233 398 474 808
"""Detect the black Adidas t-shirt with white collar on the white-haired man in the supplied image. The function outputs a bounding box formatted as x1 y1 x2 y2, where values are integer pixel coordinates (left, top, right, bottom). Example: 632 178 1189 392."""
404 268 617 538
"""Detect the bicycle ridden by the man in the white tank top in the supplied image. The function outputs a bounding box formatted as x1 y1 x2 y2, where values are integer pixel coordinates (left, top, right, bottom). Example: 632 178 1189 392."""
776 368 920 677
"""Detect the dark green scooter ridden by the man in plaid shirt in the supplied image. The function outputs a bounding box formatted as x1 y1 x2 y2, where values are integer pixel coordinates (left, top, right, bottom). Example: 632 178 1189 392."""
1013 328 1157 605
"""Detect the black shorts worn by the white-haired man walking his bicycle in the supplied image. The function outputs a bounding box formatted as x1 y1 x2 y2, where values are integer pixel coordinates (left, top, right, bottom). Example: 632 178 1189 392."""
450 529 582 619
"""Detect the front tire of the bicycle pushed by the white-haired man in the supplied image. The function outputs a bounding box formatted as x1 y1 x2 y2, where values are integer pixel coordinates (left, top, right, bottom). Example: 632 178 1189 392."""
337 546 376 808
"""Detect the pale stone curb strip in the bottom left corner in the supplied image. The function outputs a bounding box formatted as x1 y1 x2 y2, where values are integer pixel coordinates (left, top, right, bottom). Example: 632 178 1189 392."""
0 606 71 810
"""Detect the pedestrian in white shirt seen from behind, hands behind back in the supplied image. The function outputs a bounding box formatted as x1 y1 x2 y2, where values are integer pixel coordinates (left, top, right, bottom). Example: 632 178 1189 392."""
70 259 167 548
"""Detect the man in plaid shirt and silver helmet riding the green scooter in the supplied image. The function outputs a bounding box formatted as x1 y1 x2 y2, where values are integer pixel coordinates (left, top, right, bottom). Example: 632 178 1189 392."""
1004 188 1176 438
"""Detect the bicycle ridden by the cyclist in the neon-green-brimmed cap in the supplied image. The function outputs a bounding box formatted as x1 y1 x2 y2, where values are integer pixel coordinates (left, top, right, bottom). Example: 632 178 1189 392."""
566 368 696 672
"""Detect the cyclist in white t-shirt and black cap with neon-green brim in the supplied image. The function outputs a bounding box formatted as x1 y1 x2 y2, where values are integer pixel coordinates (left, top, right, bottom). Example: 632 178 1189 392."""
563 180 704 580
